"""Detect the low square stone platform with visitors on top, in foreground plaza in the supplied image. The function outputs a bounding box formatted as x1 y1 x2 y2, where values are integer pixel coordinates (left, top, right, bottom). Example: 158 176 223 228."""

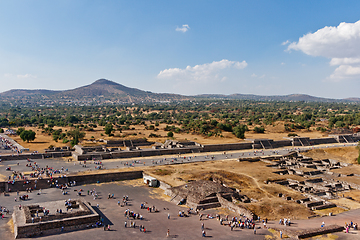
12 199 100 238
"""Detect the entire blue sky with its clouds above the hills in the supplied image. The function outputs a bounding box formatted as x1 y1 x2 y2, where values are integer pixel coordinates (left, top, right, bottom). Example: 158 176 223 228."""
0 0 360 98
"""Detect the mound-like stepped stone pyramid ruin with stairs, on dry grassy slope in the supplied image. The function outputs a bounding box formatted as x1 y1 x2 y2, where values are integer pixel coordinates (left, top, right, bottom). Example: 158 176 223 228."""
165 180 254 218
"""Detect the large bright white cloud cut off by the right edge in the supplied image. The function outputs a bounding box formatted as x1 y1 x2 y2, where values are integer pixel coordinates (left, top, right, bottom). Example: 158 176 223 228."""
287 21 360 80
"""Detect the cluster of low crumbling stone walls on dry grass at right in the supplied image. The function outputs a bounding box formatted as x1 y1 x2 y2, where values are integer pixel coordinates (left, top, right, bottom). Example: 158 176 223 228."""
261 153 358 210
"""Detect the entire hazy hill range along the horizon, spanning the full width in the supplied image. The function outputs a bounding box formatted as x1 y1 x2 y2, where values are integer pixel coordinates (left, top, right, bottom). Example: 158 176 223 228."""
0 79 360 106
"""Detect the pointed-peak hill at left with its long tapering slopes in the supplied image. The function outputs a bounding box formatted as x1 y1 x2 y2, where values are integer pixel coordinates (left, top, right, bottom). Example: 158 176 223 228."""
0 79 194 106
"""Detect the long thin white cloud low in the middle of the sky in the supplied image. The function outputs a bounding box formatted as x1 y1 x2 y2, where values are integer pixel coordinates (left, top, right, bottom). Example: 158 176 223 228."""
158 59 247 82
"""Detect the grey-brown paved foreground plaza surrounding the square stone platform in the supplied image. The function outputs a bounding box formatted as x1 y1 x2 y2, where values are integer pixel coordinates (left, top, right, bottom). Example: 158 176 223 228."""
0 182 272 240
